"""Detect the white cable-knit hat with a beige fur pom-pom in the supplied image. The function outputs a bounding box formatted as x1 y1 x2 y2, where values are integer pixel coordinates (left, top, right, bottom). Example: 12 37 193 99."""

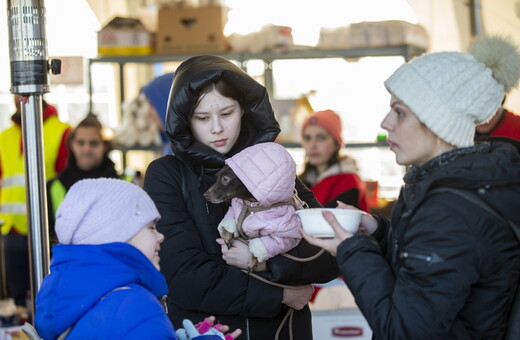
385 36 520 147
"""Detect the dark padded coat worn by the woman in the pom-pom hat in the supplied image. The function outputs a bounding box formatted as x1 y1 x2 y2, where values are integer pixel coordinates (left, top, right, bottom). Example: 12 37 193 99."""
337 139 520 339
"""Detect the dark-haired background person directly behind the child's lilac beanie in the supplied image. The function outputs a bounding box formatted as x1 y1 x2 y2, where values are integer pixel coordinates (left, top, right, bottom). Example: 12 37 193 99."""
47 113 120 246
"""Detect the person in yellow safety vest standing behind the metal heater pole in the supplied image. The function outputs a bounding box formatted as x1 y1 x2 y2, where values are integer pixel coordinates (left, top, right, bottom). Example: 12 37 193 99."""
0 95 71 306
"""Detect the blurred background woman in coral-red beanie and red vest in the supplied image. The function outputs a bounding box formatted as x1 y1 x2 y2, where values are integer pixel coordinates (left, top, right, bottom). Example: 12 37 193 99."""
299 110 368 211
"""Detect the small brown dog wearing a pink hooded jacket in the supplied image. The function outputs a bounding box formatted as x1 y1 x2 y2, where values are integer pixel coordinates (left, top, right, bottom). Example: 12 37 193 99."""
204 142 302 270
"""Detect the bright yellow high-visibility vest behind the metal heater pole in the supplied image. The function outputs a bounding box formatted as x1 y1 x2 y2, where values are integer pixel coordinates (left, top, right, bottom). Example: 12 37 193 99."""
0 116 70 235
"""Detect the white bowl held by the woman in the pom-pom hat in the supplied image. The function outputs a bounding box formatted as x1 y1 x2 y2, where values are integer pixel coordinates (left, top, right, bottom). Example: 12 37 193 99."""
296 208 366 238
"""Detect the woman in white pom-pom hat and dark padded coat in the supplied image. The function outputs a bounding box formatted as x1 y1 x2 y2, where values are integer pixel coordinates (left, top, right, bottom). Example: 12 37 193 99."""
304 37 520 339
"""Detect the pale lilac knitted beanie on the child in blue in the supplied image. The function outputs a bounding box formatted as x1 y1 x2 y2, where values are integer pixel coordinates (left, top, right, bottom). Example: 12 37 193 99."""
55 178 160 244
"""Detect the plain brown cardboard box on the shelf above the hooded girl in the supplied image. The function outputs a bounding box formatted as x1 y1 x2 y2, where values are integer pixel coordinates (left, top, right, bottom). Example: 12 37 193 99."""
157 6 228 54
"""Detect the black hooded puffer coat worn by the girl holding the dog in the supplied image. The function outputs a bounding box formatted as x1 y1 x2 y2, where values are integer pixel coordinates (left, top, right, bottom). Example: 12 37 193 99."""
144 56 338 340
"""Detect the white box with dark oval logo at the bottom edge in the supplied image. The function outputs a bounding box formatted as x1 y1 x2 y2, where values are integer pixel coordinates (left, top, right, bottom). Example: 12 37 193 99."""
312 309 372 340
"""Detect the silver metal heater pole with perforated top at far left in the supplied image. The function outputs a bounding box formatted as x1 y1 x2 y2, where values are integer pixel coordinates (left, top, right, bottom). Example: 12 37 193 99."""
7 0 59 315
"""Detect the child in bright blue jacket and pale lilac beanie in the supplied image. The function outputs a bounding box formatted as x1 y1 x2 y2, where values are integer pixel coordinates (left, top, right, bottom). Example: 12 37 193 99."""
35 178 240 340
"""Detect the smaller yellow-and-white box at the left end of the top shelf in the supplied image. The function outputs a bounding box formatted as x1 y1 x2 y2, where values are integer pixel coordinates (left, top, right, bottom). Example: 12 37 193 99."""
98 17 154 56
